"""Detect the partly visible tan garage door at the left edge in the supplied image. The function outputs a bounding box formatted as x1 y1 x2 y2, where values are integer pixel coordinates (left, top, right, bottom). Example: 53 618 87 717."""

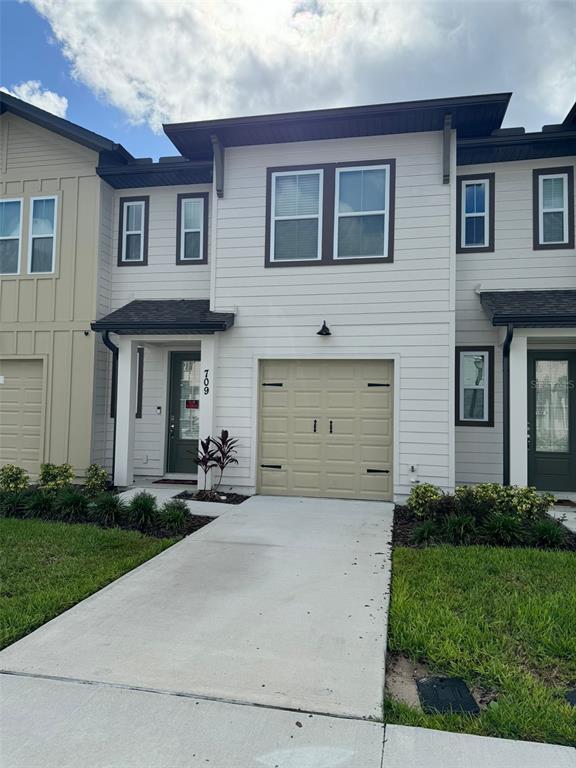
0 360 43 475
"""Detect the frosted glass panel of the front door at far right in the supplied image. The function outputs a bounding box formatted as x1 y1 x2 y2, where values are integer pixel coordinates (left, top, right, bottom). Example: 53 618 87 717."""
535 360 570 453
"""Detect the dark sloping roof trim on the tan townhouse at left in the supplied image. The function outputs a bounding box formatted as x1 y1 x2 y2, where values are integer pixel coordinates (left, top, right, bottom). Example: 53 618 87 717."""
0 91 134 162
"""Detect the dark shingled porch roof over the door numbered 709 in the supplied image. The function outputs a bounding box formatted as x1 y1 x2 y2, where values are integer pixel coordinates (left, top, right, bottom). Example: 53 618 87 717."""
91 299 234 336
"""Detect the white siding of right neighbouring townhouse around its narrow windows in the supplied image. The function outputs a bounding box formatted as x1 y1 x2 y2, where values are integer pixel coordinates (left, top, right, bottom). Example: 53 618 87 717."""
456 157 576 484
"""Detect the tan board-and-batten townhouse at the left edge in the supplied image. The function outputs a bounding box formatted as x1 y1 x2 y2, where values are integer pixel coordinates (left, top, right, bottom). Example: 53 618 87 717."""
0 93 133 477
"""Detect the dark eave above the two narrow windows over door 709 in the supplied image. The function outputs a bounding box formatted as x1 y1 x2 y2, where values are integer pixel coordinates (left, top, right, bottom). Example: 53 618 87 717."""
96 158 212 189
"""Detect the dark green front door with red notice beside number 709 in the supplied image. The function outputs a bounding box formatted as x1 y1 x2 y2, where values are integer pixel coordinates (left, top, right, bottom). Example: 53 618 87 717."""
167 352 200 474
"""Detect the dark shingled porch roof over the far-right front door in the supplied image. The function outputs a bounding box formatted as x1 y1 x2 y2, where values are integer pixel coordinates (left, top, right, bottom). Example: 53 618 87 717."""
480 290 576 328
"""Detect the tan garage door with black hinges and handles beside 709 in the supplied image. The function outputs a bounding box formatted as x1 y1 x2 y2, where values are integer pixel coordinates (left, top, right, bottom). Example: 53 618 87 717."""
258 360 394 499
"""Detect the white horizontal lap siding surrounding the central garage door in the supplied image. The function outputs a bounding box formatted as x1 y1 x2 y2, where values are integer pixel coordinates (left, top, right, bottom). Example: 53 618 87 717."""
213 133 455 497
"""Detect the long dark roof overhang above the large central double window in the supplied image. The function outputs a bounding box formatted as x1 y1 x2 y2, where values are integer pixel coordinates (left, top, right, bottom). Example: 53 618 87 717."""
164 93 511 159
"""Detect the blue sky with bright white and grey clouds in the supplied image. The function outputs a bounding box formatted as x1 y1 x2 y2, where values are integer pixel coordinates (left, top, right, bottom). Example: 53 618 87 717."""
0 0 576 158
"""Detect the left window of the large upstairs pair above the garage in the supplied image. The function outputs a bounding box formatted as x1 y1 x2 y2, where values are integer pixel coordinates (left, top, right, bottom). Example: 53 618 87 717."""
270 170 324 262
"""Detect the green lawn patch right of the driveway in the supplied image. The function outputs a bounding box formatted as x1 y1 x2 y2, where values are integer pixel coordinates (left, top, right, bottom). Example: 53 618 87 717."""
384 546 576 745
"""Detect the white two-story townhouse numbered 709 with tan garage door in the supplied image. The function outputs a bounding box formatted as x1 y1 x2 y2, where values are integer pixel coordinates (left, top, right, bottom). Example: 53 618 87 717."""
93 94 509 499
